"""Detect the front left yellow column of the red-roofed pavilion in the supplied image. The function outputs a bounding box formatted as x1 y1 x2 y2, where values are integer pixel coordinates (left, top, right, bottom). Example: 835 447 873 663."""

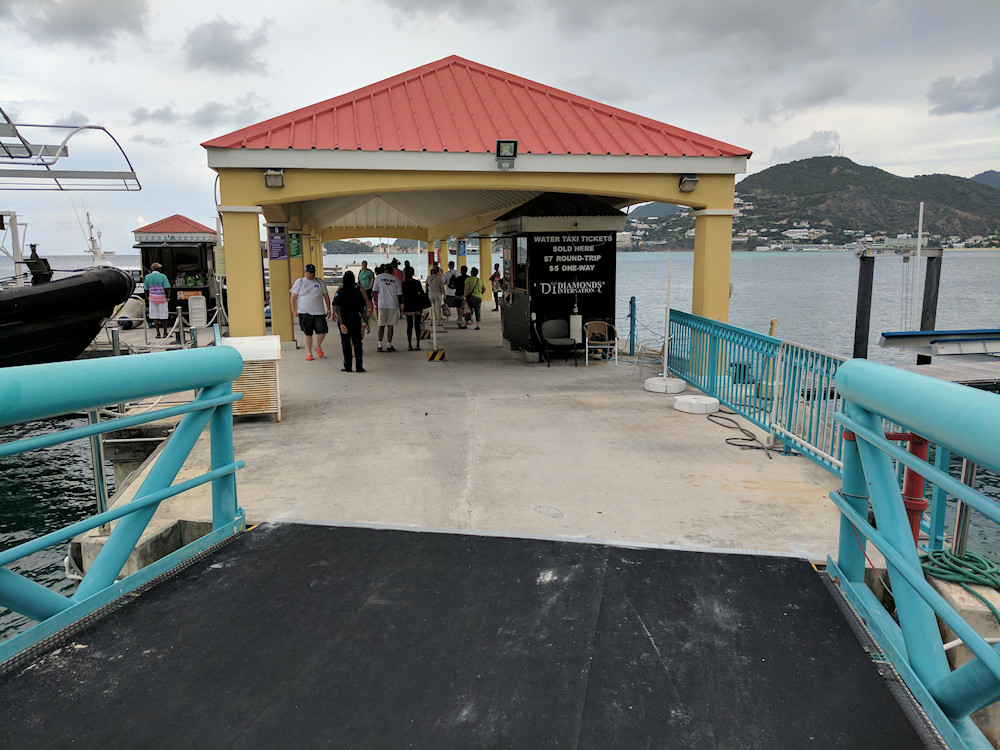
222 211 264 336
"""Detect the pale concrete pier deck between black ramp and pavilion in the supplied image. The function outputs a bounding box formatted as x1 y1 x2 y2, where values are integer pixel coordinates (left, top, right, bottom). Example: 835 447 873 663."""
95 311 839 562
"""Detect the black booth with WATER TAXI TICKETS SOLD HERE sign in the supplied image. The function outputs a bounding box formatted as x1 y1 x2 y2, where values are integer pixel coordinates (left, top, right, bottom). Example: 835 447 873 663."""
494 193 625 351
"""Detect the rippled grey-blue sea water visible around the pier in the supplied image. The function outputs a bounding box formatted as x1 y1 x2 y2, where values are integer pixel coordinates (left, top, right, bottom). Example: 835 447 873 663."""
0 250 1000 638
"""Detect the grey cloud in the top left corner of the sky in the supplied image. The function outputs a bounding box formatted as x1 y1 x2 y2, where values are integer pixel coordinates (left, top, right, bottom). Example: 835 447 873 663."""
0 0 149 49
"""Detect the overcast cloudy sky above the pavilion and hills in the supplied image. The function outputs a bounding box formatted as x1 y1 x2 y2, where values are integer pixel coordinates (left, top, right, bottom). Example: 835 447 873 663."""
0 0 1000 255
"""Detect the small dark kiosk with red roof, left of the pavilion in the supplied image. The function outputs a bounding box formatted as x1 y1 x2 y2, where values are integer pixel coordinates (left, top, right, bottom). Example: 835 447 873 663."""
132 215 220 320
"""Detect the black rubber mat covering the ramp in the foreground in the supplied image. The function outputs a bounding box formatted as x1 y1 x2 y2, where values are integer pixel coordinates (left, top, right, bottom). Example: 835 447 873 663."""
0 524 926 750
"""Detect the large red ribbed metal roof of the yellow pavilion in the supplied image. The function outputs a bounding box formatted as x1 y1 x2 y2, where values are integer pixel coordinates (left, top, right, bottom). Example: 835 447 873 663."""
201 55 751 157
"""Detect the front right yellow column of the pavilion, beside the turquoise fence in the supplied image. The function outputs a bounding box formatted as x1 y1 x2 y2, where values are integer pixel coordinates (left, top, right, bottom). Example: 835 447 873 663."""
691 208 734 323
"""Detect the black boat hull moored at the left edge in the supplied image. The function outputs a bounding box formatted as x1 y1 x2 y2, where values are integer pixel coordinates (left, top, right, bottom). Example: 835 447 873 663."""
0 268 135 367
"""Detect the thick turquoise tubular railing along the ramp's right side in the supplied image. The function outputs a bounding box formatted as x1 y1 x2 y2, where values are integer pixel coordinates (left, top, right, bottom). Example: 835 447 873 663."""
827 360 1000 748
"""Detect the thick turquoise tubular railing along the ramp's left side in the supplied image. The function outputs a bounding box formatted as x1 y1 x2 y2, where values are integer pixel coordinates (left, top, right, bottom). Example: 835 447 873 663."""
0 347 243 662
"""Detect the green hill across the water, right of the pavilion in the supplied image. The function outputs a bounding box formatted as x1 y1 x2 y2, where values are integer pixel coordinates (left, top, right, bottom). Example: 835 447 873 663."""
736 156 1000 237
